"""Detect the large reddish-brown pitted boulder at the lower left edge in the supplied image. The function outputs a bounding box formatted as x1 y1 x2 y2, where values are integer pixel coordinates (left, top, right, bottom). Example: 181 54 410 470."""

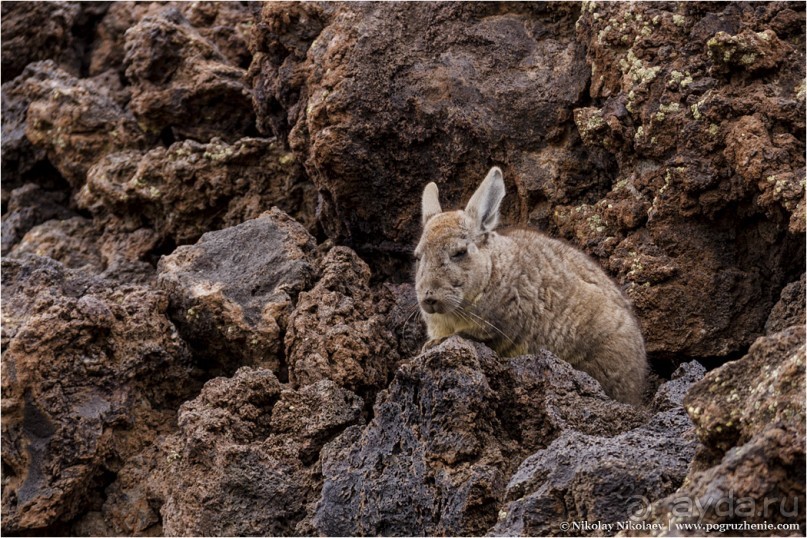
2 256 193 533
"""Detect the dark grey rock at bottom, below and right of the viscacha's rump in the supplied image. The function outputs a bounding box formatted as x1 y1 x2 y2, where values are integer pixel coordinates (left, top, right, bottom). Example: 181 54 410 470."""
492 362 705 536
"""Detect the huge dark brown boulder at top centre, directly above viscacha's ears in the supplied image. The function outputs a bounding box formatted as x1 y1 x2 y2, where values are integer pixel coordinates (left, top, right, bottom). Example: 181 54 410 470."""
250 3 603 256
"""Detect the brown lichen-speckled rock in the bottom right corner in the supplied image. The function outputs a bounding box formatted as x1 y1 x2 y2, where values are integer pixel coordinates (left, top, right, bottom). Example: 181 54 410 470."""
645 324 807 536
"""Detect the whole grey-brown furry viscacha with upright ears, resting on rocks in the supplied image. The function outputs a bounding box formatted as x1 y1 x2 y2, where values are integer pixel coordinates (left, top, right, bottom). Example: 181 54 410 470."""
415 168 647 404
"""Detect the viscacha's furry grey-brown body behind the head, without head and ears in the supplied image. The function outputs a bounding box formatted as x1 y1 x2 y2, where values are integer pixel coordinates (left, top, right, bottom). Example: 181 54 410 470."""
486 229 647 403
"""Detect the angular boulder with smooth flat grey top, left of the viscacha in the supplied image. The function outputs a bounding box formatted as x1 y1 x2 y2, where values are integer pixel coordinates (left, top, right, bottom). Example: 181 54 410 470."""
158 208 315 374
